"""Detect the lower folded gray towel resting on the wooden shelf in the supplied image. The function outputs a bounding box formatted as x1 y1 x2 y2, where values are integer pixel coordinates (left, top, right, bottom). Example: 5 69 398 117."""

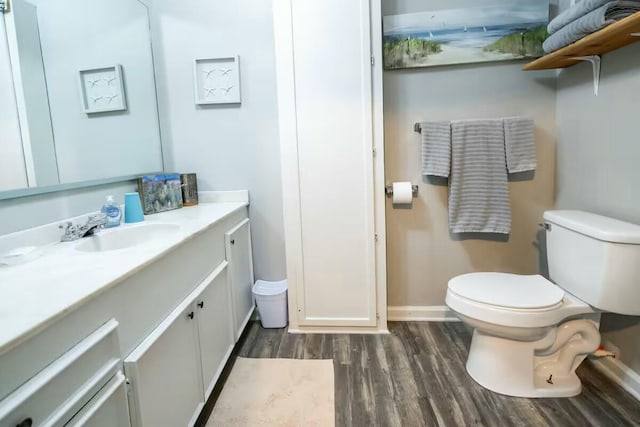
542 0 640 53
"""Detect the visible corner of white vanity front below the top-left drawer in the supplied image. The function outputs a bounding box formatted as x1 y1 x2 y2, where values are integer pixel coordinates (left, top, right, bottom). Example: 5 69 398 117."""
66 371 131 427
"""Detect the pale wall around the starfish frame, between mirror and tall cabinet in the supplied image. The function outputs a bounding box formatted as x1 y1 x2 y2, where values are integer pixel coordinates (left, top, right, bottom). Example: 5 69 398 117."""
150 0 285 280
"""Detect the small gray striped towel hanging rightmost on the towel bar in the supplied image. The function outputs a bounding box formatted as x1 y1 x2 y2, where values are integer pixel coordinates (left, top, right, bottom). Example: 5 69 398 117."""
504 117 536 173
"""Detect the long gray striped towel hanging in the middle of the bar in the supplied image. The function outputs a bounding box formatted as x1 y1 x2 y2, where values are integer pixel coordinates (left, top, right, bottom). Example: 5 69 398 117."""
449 119 511 234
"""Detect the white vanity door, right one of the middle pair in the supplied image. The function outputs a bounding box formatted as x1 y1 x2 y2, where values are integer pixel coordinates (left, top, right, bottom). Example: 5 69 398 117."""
196 263 234 401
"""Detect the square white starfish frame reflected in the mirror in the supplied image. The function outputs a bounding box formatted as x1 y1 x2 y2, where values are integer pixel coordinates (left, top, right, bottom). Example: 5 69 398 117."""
79 64 127 114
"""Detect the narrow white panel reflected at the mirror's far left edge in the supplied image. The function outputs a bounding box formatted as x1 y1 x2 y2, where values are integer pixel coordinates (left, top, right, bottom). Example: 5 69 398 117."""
0 15 27 192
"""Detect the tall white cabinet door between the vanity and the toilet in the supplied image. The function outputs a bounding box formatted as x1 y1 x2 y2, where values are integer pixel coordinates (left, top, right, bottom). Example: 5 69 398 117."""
273 0 376 326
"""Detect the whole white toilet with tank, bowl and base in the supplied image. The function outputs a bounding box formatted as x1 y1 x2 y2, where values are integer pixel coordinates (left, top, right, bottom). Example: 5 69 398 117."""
446 211 640 397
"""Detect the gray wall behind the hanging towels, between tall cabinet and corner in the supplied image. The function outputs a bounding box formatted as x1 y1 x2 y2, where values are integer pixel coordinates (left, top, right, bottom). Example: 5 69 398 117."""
383 0 556 306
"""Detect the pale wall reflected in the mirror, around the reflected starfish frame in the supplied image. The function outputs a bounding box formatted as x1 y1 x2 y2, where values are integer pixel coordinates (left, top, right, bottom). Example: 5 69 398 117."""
37 0 162 184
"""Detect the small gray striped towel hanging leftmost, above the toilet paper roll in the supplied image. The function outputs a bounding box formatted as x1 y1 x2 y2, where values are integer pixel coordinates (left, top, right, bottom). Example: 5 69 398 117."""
420 122 451 178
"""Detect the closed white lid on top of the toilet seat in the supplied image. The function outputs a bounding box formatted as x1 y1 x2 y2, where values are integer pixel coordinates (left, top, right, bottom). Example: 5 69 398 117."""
449 273 564 309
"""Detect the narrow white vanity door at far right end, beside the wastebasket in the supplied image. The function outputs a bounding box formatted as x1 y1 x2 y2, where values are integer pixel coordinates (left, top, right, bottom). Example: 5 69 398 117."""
224 219 255 341
